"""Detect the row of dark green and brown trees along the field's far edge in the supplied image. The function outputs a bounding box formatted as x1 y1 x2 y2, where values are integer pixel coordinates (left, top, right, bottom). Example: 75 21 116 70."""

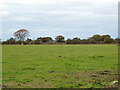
2 29 120 45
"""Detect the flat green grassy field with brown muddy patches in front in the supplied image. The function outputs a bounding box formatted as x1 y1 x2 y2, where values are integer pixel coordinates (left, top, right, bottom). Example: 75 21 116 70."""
2 45 118 88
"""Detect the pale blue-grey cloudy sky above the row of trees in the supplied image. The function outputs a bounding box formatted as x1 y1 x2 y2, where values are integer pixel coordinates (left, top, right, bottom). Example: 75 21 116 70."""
0 0 118 40
